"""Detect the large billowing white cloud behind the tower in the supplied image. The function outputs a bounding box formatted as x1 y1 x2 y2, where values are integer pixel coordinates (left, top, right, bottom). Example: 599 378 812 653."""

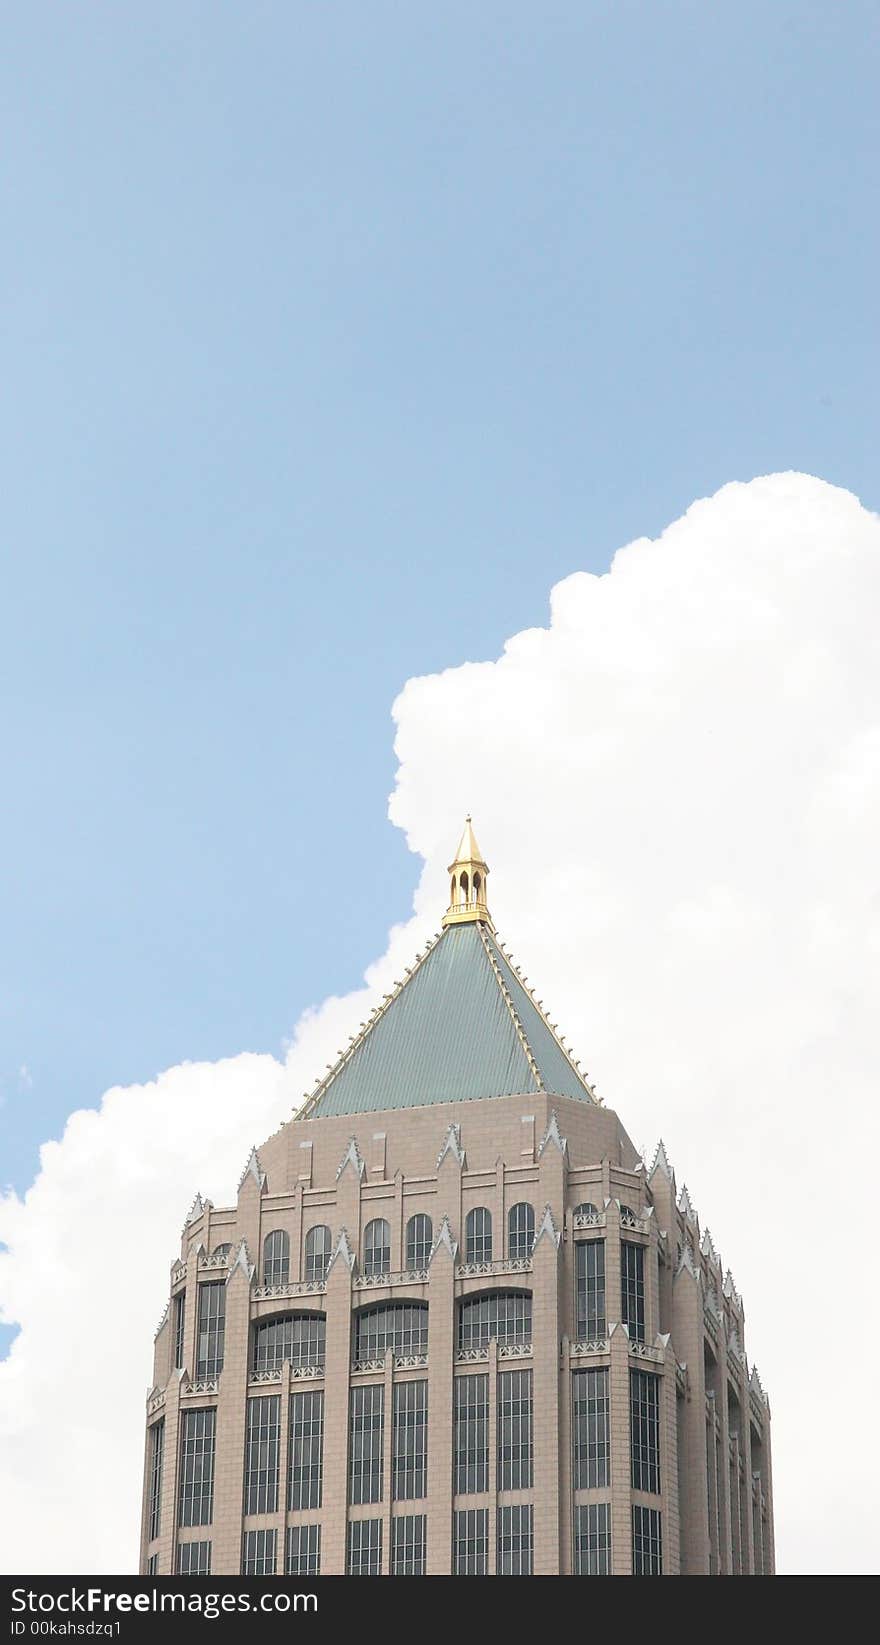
0 474 880 1571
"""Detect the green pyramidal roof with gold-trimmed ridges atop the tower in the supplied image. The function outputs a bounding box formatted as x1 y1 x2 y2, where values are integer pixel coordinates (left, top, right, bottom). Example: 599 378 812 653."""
299 921 595 1119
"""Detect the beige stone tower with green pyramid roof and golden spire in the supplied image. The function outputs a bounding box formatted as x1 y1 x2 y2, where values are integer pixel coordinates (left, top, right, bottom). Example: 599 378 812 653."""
141 819 773 1576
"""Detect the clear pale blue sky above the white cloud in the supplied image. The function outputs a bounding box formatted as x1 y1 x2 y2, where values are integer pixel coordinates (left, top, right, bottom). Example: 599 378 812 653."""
0 0 880 1237
